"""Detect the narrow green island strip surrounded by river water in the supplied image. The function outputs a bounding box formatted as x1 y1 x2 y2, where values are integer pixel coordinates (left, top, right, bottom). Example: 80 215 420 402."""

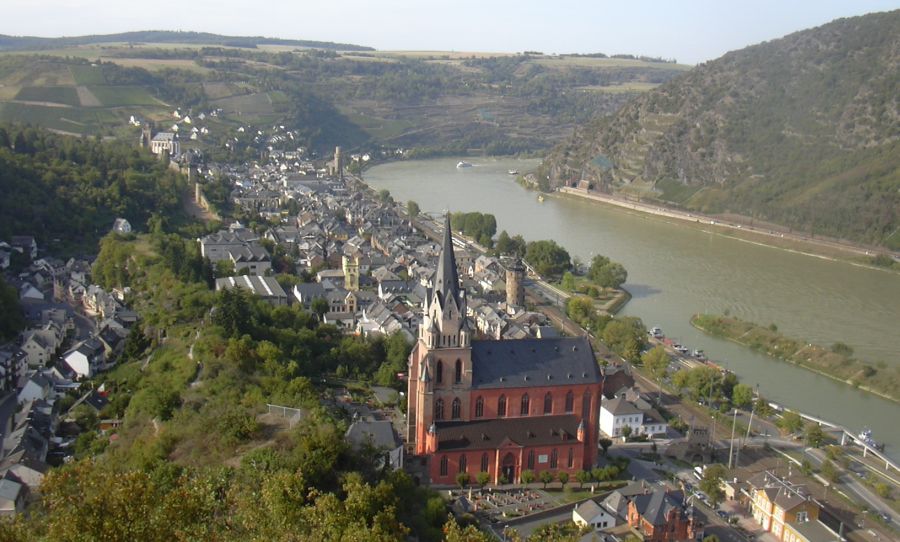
691 314 900 403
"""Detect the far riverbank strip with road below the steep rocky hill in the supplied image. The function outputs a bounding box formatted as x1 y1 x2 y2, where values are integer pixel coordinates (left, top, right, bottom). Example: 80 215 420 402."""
557 187 900 273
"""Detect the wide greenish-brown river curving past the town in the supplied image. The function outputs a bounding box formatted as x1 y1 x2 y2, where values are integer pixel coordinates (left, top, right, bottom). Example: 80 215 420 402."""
364 158 900 458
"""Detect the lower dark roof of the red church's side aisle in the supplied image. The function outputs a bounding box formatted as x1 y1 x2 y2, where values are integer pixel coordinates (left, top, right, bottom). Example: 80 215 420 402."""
435 414 580 451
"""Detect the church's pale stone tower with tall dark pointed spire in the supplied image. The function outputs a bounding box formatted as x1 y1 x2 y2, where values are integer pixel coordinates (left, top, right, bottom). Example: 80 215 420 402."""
407 215 472 454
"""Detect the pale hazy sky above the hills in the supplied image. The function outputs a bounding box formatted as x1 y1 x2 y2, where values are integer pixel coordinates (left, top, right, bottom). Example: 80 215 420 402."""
0 0 900 63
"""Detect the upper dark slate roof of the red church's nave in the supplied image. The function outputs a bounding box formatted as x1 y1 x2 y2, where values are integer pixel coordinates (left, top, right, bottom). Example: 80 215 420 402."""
472 337 600 388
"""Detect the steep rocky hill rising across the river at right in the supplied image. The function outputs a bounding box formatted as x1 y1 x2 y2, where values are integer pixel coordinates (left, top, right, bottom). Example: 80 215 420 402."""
542 11 900 249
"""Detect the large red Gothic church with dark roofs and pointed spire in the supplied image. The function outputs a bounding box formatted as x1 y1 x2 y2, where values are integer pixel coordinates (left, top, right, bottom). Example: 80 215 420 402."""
407 216 602 485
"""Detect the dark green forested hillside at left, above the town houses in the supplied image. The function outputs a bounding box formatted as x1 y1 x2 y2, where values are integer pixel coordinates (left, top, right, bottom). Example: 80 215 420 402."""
0 125 186 255
